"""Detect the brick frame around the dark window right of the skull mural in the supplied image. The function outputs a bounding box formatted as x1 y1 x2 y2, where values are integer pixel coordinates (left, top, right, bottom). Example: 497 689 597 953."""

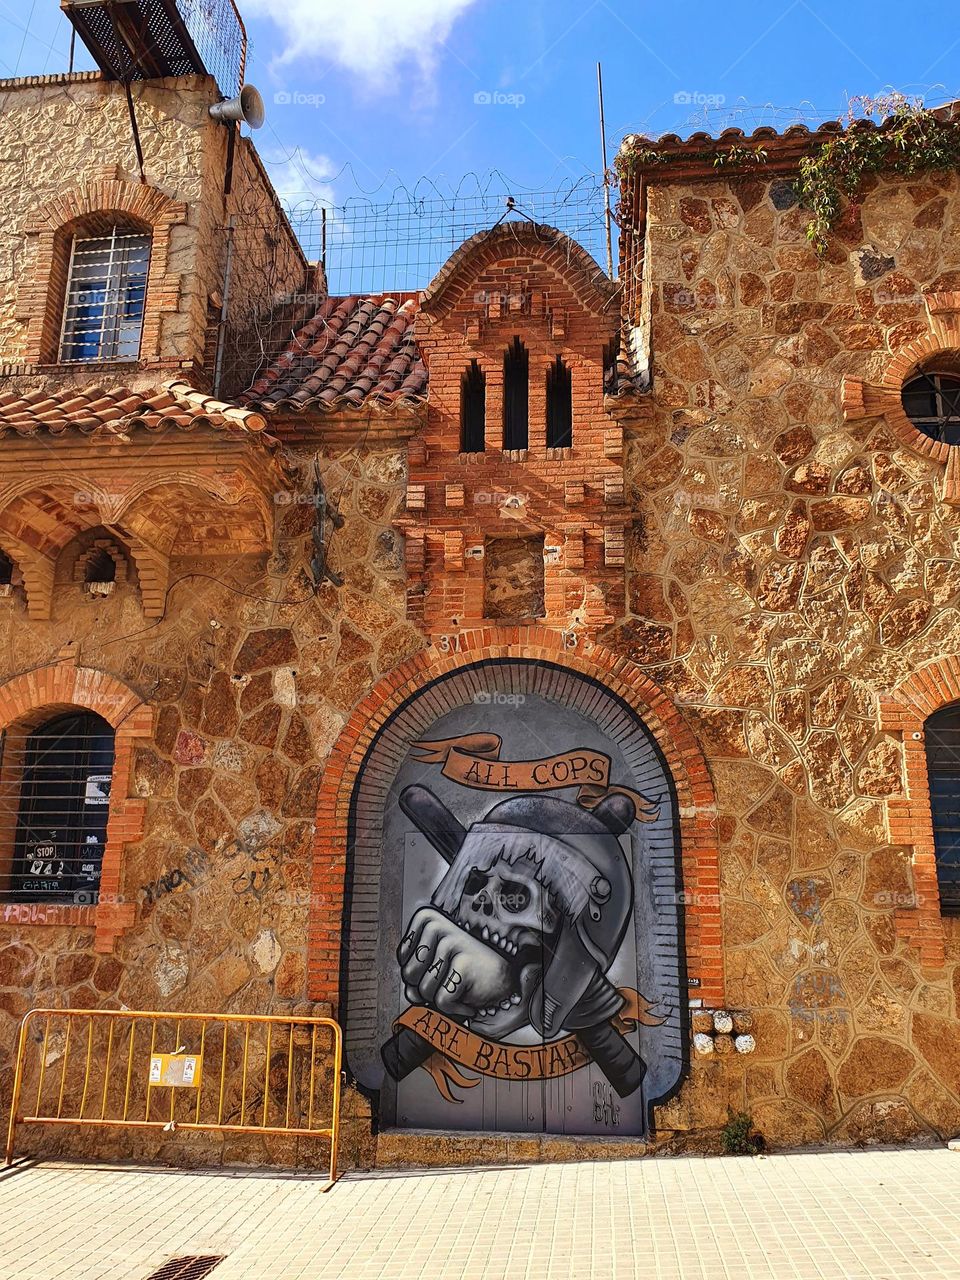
879 655 960 969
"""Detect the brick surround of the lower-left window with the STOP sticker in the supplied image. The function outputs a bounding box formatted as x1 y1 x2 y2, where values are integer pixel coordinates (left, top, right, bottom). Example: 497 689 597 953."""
0 662 154 951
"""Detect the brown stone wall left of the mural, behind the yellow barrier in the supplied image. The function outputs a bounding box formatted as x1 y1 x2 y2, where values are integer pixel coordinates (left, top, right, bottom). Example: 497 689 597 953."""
0 451 421 1165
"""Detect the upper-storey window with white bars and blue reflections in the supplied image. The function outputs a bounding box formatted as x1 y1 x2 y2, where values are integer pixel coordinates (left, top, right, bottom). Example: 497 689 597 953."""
60 227 150 364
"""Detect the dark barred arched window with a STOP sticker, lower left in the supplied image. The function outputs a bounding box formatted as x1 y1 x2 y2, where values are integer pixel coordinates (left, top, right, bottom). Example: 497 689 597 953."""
0 710 114 905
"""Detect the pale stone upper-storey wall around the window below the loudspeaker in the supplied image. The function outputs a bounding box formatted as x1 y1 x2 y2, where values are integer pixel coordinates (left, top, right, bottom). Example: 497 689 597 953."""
0 72 307 389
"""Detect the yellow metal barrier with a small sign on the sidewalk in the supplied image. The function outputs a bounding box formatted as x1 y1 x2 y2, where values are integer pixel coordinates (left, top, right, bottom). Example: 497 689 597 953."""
6 1009 343 1190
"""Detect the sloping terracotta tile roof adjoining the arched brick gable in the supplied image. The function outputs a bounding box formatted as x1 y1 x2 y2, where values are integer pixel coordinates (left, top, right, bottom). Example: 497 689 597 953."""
241 293 426 413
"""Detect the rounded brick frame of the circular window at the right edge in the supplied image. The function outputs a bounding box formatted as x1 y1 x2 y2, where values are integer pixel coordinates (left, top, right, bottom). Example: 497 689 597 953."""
841 291 960 506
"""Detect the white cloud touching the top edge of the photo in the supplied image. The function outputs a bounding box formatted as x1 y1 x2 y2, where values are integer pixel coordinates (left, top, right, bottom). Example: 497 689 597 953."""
246 0 477 88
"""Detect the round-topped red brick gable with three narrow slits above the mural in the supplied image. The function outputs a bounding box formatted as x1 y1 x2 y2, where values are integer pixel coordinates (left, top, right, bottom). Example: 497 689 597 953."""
399 224 632 635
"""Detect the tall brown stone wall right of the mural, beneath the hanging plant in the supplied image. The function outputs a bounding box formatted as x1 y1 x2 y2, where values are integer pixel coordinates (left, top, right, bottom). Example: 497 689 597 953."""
605 167 960 1143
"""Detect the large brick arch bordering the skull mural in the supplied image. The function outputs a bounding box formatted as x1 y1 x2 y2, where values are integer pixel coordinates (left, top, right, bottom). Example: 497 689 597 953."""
307 626 723 1006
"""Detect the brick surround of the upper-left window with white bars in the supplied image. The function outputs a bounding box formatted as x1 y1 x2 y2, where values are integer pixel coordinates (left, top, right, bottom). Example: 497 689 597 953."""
17 169 187 365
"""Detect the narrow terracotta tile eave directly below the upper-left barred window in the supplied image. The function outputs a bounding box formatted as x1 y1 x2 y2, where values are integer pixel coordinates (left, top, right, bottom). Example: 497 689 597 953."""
0 381 266 438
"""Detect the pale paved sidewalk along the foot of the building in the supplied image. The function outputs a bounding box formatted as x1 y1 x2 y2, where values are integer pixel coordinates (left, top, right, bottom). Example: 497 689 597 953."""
0 1148 960 1280
